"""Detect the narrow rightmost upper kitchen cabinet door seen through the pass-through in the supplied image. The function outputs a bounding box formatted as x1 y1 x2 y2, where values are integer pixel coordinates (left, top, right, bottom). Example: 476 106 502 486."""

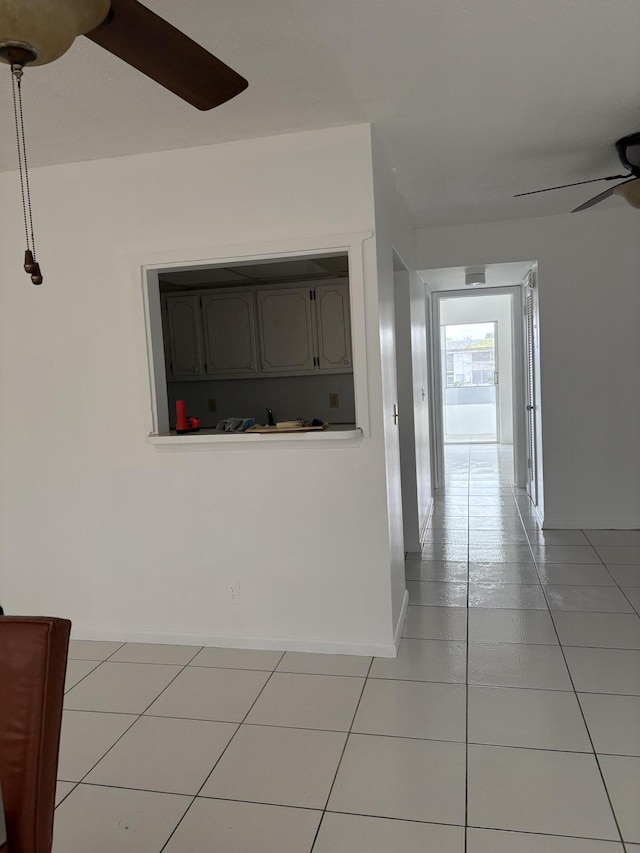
315 284 352 373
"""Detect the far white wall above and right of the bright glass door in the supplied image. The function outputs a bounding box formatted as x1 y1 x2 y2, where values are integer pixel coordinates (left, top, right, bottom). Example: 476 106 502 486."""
440 290 524 444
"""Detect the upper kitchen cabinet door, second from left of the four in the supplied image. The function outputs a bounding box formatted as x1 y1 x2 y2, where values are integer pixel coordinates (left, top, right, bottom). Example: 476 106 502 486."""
202 292 258 378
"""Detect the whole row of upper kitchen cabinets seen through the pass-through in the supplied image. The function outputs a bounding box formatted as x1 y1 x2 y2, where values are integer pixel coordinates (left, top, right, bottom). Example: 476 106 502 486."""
163 281 353 381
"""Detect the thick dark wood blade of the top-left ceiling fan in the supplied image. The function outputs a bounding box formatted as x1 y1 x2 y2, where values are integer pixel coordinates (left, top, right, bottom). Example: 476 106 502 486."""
85 0 249 110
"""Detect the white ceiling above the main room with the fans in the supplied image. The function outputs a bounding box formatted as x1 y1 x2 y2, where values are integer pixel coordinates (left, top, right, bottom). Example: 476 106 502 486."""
0 0 640 226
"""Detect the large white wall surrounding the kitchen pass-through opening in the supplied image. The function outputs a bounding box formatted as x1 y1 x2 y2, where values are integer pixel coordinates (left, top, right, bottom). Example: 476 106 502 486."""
0 125 395 654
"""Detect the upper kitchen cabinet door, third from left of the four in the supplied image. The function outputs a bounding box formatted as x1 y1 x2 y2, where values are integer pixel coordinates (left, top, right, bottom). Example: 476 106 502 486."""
257 288 315 374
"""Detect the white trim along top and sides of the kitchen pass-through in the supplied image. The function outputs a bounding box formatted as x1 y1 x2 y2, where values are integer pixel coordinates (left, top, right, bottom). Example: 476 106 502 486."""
135 231 373 446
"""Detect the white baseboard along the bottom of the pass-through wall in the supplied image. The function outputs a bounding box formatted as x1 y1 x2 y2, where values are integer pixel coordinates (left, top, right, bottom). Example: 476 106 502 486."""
71 624 400 658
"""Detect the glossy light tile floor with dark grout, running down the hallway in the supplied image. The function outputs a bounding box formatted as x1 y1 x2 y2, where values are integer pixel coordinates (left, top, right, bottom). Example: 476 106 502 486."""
54 445 640 853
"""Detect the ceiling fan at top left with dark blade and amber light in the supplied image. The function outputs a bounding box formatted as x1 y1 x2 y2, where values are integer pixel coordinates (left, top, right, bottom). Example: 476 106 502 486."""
0 0 248 110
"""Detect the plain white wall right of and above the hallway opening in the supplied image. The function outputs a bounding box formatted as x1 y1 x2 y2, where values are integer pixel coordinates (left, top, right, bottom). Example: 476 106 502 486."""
416 207 640 528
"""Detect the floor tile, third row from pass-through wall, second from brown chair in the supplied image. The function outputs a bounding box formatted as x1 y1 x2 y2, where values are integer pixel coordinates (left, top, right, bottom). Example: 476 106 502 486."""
85 717 237 794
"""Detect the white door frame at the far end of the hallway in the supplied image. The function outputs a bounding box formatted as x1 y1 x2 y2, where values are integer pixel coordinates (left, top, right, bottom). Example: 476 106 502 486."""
431 282 527 488
